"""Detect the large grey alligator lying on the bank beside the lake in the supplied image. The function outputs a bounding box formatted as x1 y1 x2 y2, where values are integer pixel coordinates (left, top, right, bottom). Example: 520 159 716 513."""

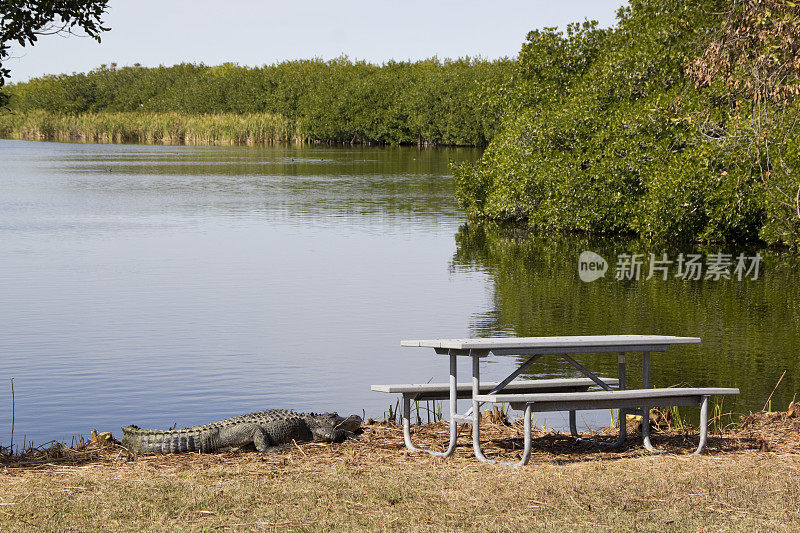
122 409 361 454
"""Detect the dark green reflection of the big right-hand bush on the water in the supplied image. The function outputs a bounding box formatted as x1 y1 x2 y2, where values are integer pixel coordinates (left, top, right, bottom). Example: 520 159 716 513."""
451 225 800 412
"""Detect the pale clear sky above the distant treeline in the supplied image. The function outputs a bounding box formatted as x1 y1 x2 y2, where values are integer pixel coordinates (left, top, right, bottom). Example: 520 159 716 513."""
5 0 627 82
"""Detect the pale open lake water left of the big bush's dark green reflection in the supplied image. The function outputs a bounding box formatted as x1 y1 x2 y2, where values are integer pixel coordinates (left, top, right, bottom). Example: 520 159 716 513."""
0 141 487 445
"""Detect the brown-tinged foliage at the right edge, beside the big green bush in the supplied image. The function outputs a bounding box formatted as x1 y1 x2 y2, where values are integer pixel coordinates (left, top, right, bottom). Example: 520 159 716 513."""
687 0 800 245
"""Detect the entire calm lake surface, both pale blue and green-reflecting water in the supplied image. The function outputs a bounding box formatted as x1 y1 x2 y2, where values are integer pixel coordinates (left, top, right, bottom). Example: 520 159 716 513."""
0 141 800 446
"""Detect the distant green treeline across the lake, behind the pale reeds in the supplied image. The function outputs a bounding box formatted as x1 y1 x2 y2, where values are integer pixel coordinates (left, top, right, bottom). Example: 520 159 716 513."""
4 57 510 146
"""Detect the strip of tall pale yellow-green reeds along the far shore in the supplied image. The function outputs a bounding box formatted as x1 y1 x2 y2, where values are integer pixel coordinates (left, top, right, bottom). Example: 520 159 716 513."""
0 110 302 144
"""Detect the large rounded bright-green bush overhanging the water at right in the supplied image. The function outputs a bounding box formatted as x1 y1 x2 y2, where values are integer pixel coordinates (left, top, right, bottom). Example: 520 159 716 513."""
455 0 798 244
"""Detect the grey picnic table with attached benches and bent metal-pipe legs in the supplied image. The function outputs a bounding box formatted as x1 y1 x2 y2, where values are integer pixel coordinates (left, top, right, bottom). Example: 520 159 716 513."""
372 335 739 465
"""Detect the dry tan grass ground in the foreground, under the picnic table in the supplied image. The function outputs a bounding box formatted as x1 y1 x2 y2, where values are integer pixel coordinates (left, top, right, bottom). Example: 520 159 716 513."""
0 413 800 532
